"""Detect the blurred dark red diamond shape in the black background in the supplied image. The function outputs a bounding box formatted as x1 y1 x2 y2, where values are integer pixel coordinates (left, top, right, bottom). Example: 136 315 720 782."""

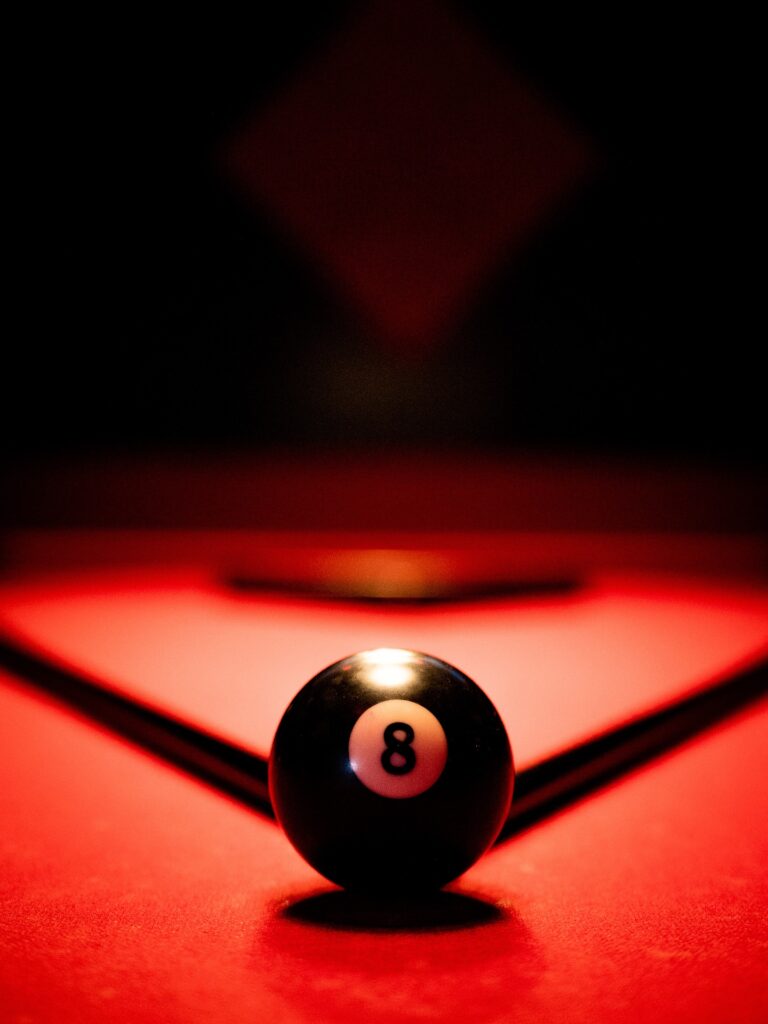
224 2 596 350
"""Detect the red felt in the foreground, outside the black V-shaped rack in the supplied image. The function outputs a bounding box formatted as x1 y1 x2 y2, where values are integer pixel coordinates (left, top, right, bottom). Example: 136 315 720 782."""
0 678 768 1024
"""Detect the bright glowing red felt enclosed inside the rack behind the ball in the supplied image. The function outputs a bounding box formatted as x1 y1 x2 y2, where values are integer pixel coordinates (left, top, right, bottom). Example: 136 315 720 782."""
0 573 768 767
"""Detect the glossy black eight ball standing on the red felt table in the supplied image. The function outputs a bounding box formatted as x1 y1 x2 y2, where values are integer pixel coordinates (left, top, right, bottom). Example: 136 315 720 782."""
269 648 514 893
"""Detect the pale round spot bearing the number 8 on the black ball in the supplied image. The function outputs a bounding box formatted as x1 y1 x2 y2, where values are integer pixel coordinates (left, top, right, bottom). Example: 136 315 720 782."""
349 700 447 800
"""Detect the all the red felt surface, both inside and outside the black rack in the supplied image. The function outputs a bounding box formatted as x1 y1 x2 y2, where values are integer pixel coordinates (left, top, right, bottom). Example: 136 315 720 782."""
0 573 768 1024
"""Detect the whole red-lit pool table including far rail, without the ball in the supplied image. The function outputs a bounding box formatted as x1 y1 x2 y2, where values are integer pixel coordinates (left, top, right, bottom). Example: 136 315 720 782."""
0 460 768 1024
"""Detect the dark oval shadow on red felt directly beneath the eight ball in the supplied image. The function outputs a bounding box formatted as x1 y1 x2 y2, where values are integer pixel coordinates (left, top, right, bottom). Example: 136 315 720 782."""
281 890 505 932
